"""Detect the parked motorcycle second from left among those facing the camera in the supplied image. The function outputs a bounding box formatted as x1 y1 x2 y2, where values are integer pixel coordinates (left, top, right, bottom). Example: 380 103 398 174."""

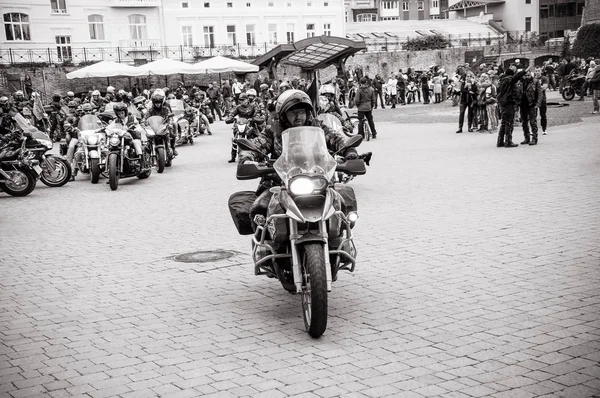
106 123 152 191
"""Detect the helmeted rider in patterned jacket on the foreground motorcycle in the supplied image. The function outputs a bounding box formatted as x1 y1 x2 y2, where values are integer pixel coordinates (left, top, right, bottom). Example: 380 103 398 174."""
238 89 358 227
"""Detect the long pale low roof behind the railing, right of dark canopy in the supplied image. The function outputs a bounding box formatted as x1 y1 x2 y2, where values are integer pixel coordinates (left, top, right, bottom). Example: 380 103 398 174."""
346 19 500 41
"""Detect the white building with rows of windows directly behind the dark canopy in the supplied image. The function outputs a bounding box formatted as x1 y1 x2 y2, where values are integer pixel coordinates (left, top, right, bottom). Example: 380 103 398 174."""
163 0 344 56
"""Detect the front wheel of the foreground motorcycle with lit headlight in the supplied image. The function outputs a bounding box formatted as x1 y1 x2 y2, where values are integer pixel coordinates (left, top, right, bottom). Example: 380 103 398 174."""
300 242 327 338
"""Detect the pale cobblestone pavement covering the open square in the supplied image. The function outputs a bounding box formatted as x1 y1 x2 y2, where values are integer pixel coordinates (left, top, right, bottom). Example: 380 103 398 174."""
0 119 600 398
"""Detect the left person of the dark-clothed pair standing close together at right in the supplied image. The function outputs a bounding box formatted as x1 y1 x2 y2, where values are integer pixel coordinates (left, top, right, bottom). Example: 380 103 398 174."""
496 64 529 148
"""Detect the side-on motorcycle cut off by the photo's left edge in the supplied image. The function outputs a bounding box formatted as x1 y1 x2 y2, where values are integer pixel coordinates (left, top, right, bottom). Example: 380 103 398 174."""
0 132 42 196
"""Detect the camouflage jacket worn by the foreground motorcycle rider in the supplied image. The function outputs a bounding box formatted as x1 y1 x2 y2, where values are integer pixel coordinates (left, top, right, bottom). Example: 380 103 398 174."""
238 119 357 164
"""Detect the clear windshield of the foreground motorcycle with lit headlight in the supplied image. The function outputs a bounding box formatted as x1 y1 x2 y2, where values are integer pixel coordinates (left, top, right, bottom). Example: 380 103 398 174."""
273 126 337 185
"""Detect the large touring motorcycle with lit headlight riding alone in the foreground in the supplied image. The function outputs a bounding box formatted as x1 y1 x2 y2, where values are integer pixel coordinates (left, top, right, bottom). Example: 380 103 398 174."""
230 127 366 338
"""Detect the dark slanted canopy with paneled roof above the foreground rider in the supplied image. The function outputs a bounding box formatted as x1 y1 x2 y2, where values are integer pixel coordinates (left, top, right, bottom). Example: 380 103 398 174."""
253 36 367 80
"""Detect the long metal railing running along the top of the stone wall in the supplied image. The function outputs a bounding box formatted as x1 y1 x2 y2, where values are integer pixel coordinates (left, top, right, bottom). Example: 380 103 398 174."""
0 32 563 65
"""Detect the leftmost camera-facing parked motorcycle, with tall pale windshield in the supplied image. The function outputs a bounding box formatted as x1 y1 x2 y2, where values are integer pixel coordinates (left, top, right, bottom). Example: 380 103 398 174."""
74 115 108 184
